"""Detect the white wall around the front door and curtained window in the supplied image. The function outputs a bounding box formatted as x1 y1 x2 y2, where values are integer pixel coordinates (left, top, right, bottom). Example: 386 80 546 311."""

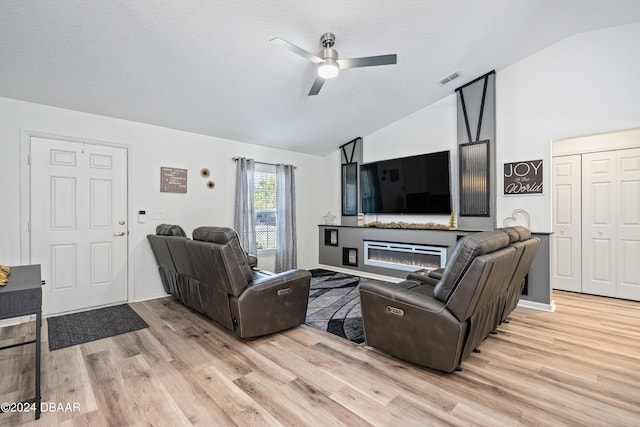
0 98 334 299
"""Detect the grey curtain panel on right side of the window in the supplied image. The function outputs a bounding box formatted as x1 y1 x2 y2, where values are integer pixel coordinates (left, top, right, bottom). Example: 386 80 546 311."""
275 164 298 273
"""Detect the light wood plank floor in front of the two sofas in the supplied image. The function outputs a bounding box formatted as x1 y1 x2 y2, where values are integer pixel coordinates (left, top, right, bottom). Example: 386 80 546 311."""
0 292 640 427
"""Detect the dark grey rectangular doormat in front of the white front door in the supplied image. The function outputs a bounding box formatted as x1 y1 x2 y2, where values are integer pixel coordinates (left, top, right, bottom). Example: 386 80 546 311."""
47 304 149 351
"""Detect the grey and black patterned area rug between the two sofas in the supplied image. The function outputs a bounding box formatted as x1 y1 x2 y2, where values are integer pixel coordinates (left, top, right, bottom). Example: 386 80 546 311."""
305 269 372 344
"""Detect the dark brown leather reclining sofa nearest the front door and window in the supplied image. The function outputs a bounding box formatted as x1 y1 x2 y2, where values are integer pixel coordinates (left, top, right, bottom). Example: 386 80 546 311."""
147 224 311 338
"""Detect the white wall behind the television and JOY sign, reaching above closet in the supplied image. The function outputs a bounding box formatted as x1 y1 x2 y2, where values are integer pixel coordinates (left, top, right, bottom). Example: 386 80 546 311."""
356 23 640 232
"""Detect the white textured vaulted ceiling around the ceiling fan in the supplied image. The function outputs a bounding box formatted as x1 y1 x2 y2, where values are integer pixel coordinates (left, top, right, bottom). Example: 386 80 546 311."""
0 0 640 155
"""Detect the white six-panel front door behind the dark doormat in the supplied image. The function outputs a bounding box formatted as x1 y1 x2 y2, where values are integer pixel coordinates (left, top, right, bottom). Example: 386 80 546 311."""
30 137 128 315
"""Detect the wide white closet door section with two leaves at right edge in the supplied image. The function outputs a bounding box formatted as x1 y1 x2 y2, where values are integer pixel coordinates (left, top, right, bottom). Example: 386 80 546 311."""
582 148 640 301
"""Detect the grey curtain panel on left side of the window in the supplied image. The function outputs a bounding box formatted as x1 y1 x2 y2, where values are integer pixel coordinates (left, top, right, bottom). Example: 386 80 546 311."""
233 157 256 255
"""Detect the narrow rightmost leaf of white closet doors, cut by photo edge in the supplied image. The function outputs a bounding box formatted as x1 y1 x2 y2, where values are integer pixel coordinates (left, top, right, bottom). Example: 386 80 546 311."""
616 148 640 301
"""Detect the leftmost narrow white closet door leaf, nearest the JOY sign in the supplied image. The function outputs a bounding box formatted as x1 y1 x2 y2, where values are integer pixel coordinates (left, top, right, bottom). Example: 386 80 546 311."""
551 154 582 292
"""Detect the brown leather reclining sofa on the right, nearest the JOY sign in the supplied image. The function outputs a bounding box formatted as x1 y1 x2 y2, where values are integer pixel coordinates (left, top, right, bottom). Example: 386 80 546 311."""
360 227 540 372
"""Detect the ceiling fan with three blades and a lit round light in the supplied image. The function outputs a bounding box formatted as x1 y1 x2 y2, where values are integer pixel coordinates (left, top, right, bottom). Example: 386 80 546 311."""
271 33 397 96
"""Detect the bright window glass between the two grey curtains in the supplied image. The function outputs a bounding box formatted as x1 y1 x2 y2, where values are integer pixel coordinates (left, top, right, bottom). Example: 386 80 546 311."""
253 164 278 251
